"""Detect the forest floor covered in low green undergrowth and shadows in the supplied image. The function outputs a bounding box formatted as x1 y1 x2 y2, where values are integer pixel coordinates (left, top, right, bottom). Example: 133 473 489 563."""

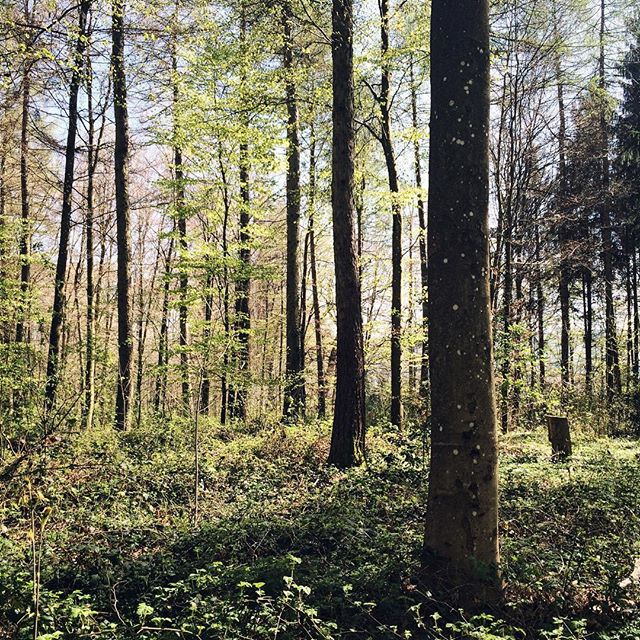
0 421 640 640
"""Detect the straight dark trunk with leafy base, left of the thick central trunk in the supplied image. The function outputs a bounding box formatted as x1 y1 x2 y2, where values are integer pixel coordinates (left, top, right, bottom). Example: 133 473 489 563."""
282 0 305 422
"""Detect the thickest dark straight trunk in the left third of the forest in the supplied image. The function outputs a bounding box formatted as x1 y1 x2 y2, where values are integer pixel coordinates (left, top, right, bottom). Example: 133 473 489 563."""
111 0 132 431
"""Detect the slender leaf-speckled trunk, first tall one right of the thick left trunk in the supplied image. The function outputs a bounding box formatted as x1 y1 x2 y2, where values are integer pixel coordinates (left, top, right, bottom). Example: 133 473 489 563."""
171 41 191 415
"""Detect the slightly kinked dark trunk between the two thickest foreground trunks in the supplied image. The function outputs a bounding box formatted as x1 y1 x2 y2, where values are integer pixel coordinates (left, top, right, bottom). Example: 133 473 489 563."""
379 0 402 427
